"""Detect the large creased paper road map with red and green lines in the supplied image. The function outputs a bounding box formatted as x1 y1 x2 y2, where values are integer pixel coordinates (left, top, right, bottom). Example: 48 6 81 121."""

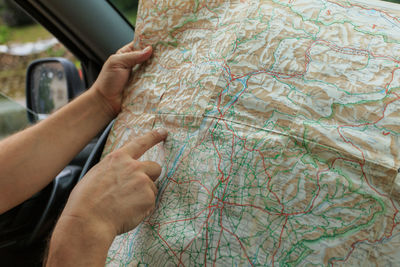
104 0 400 266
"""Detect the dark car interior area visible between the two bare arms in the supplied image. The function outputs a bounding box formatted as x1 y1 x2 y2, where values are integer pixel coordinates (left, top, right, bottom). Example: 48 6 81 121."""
0 121 114 266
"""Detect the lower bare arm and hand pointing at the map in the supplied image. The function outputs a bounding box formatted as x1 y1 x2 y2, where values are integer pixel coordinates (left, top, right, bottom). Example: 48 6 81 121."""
47 130 167 267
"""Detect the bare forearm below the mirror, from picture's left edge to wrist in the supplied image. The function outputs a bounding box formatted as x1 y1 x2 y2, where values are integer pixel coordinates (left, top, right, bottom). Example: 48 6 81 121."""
0 89 113 214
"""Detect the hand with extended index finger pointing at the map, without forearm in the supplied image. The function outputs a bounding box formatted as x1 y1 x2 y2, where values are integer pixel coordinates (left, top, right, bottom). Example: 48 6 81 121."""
60 130 168 238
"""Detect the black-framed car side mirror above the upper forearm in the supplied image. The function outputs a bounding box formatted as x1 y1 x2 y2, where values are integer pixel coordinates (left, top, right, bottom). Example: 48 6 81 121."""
26 58 85 123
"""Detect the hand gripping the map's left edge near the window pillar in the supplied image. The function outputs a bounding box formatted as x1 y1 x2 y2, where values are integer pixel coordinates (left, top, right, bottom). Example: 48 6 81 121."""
93 42 153 117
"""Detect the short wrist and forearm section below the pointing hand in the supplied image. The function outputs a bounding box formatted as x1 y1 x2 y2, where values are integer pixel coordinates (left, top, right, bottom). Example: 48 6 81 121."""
46 217 114 267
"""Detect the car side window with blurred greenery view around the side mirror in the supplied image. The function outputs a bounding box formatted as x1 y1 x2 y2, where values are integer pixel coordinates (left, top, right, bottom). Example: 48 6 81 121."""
0 0 80 139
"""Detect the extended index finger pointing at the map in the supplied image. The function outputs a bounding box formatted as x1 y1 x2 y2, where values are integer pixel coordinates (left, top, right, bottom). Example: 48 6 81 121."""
122 128 168 159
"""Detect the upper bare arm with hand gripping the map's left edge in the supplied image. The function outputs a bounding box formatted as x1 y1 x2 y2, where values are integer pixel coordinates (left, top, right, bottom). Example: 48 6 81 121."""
0 44 151 214
